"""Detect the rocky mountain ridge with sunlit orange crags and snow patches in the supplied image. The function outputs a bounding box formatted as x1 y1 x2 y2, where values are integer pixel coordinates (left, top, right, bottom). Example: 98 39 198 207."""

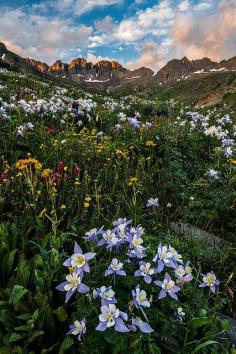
0 43 236 90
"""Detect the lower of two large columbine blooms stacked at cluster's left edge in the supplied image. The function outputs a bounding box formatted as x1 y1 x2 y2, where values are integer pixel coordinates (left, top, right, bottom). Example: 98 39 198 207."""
56 272 89 303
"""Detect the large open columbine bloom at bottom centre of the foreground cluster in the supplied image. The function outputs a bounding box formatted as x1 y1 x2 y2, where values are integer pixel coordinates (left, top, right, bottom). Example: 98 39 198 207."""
96 304 129 333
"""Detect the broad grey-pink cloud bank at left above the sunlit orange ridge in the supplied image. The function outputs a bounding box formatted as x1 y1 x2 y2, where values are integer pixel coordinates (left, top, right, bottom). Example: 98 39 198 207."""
0 10 92 63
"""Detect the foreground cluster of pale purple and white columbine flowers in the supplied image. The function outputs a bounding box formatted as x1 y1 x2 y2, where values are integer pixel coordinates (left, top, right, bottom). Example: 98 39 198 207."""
56 218 220 340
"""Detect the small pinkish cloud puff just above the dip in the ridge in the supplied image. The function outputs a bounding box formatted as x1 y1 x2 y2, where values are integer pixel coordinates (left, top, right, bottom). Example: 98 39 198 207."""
124 41 165 71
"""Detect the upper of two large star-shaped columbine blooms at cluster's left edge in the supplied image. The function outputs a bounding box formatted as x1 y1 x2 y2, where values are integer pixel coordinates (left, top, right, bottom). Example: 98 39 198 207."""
63 242 96 277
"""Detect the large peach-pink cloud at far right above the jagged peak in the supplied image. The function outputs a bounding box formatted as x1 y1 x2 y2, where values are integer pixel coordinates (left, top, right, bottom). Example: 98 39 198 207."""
170 0 236 61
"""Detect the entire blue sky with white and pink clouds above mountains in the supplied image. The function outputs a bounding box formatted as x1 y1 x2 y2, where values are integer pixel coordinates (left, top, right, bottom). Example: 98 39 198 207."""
0 0 236 71
